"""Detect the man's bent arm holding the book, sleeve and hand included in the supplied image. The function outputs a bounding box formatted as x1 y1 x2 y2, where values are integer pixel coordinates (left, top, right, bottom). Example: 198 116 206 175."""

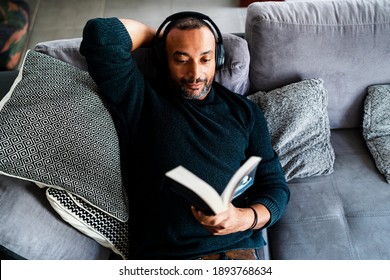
192 103 290 235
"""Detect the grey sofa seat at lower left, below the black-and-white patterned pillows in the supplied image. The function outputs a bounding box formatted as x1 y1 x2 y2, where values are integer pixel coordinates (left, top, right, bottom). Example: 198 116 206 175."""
0 175 111 260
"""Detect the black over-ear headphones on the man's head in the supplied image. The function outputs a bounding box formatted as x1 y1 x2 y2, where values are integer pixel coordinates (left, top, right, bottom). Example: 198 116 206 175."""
153 12 225 69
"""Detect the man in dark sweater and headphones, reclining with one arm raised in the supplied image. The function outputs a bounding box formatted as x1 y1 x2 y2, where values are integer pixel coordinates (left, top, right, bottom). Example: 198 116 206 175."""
80 13 289 259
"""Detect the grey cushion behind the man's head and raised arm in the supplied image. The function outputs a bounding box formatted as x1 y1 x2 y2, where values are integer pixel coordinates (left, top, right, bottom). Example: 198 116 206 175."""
34 34 250 95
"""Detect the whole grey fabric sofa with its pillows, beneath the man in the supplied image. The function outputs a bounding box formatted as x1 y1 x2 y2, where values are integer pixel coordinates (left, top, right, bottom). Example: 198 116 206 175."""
0 0 390 260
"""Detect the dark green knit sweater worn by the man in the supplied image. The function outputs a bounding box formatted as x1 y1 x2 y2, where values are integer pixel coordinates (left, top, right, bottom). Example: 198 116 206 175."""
80 18 289 259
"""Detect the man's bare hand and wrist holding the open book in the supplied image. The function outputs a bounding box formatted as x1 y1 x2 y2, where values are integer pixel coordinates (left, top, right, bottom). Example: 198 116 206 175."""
191 203 270 235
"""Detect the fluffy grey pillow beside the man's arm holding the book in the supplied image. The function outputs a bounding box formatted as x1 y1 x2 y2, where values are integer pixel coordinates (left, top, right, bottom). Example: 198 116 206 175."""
248 79 335 180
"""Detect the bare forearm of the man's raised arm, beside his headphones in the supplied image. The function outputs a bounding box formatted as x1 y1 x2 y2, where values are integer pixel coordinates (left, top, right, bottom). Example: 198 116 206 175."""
119 19 156 51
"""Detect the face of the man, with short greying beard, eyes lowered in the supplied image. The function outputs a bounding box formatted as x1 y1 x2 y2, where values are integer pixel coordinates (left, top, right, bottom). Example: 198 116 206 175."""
166 26 215 100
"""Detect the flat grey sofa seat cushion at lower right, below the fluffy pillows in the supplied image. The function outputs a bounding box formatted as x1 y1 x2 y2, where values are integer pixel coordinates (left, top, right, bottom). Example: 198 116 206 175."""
268 129 390 260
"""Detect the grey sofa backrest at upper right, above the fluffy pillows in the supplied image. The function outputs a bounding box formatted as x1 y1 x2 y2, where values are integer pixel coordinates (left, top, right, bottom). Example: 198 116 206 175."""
245 0 390 128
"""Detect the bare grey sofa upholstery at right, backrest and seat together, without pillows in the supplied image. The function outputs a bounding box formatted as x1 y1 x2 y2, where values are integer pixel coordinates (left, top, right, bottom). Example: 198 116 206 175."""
246 0 390 260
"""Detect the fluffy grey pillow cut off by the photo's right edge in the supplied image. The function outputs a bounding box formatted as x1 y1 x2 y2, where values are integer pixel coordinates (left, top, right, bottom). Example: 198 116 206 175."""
363 84 390 184
